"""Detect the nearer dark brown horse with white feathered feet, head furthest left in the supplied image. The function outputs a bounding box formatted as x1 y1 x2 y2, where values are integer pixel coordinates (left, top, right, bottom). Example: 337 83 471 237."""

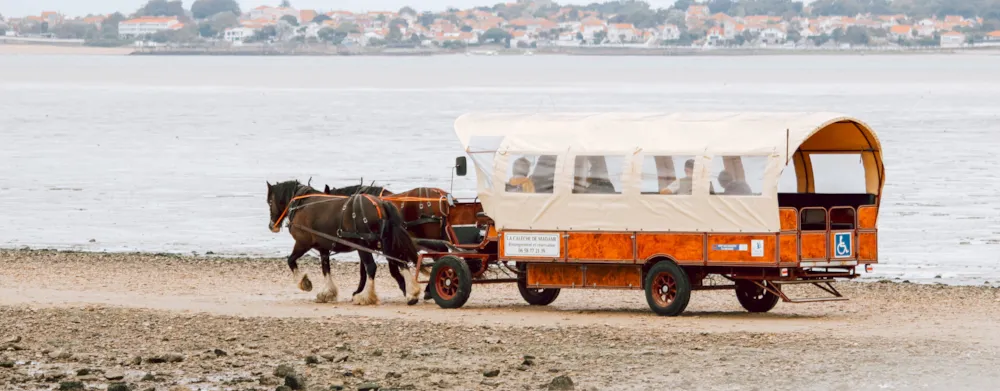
267 181 420 305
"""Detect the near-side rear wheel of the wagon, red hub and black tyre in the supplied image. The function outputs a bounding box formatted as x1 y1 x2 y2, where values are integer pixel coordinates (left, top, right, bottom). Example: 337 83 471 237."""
645 261 691 316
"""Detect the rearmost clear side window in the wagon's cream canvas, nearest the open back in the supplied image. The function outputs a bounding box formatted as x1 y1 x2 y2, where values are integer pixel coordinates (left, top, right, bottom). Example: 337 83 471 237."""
709 156 767 196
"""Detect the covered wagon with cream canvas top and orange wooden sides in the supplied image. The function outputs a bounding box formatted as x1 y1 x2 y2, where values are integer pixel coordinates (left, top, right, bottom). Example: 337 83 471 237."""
419 113 885 315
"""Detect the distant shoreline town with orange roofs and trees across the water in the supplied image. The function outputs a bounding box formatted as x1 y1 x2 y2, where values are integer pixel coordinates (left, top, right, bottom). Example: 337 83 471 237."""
0 0 1000 51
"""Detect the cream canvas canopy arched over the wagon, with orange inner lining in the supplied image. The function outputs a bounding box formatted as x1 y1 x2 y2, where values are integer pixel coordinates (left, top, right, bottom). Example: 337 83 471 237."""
455 113 885 232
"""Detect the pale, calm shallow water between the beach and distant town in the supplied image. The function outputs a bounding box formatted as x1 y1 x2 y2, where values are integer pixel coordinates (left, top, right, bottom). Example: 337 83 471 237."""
0 55 1000 284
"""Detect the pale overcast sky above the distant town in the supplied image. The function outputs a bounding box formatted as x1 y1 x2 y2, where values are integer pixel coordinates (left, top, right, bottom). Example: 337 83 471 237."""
0 0 674 17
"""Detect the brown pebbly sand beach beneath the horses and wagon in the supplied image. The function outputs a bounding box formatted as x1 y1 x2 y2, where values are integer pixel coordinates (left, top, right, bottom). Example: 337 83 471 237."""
0 251 1000 390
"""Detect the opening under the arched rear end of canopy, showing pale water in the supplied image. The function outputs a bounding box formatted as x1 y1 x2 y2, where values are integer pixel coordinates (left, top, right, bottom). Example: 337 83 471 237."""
809 153 868 194
